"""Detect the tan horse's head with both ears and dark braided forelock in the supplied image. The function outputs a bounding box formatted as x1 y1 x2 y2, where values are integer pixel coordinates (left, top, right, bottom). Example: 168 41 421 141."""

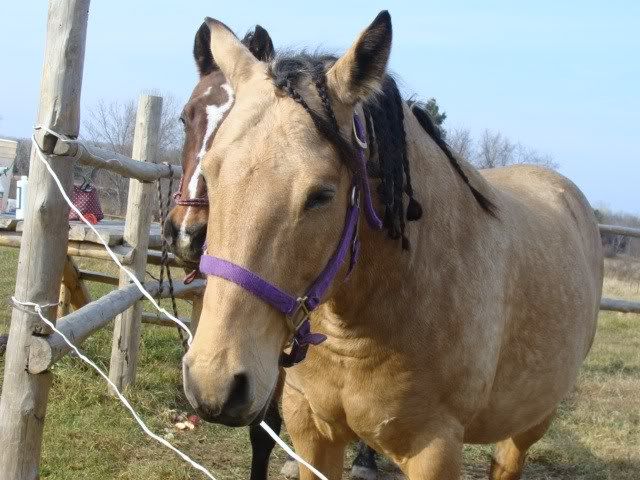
183 12 391 425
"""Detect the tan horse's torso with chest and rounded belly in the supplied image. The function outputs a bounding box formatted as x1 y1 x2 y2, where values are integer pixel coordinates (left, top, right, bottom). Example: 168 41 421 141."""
284 145 602 472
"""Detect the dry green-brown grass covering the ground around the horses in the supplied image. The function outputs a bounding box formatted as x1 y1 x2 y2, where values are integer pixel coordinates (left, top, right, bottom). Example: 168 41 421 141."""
0 249 640 480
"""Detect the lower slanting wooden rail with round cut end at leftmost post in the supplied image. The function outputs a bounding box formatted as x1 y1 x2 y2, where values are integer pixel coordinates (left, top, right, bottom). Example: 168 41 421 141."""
27 279 205 374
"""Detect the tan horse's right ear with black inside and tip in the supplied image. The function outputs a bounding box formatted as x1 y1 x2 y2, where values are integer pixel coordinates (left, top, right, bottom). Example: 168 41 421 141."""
327 10 392 105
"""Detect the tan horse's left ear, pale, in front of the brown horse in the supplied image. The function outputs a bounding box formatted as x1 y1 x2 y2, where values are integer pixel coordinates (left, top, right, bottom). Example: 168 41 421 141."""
205 17 258 89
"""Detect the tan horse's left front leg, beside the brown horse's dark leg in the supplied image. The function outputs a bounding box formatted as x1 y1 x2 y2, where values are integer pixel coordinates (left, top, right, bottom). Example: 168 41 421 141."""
282 385 347 480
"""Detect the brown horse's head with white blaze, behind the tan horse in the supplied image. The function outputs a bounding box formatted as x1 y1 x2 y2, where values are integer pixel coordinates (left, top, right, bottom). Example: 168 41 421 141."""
163 23 273 263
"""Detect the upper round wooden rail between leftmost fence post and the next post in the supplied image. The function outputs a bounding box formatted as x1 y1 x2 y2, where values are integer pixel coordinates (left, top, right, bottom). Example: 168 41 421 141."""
35 131 182 182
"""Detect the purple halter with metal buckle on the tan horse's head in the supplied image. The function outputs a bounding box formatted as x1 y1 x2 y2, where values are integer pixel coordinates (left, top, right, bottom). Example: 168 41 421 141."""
200 114 382 367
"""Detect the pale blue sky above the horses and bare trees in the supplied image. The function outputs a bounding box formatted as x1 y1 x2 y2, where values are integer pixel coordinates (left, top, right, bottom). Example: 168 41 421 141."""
0 0 640 214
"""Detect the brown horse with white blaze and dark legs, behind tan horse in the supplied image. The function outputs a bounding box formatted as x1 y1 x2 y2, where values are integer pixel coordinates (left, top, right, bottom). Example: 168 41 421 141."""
165 19 377 480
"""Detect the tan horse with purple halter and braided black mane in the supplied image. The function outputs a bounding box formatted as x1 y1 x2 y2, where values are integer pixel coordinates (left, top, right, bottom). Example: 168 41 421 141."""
183 11 603 480
